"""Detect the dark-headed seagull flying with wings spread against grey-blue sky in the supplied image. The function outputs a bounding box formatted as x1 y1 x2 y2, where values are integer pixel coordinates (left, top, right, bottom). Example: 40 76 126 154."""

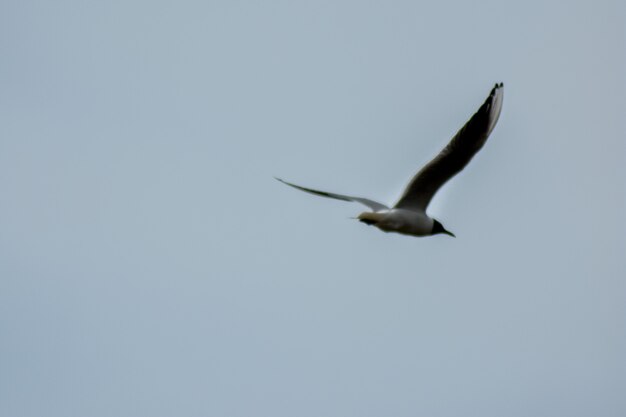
276 83 504 237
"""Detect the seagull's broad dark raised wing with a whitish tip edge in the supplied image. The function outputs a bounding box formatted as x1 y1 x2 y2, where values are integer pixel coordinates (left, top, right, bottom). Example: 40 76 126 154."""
395 83 504 211
